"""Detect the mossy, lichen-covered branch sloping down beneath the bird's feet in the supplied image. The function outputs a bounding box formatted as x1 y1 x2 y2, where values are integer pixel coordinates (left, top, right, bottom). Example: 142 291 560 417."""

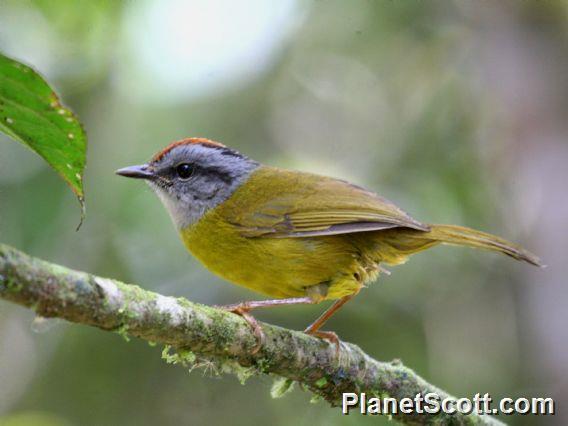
0 244 506 424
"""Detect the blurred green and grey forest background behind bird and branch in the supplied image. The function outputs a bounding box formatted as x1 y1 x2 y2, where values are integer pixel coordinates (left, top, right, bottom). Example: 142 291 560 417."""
0 0 568 426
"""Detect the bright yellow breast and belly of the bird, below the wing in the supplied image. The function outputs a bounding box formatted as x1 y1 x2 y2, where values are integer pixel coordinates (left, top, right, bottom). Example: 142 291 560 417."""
182 209 377 299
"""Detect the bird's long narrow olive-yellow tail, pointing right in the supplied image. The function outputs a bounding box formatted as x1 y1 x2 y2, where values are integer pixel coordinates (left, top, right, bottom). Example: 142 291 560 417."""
422 225 544 267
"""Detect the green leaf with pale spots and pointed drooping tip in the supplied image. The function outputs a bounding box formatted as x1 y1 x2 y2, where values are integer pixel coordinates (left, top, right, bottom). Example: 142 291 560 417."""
0 50 87 219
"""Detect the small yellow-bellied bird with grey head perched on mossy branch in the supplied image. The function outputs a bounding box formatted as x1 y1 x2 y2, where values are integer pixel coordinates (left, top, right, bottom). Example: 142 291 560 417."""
116 138 542 349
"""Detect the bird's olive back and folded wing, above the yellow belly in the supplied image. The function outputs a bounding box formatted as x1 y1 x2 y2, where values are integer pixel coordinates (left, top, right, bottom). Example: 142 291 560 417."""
226 167 429 238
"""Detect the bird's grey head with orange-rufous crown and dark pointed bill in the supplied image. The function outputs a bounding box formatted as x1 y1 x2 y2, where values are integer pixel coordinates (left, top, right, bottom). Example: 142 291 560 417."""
116 138 259 229
